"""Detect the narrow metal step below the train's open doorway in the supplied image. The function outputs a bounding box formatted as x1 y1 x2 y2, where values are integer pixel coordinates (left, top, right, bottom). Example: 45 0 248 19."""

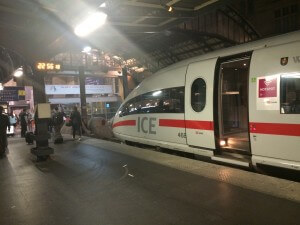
211 154 251 168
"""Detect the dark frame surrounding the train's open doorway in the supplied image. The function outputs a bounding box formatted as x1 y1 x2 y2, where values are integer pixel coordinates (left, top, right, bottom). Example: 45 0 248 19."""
213 51 253 155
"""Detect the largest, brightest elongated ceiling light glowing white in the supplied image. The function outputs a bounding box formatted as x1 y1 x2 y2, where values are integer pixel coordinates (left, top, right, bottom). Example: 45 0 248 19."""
74 12 107 37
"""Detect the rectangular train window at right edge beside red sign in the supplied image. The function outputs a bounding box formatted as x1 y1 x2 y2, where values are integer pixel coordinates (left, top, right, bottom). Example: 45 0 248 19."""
280 74 300 114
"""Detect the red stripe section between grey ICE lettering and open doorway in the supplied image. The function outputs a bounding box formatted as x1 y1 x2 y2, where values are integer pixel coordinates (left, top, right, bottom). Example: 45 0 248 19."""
159 119 214 130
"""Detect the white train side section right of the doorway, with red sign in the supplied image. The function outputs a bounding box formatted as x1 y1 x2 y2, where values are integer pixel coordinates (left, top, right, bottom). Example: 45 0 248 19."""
249 42 300 168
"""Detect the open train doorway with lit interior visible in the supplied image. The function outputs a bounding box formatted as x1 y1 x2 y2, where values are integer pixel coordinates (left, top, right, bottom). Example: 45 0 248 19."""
215 57 250 153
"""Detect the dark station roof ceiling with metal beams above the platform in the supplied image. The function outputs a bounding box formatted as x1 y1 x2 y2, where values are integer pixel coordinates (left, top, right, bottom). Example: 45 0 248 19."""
0 0 298 80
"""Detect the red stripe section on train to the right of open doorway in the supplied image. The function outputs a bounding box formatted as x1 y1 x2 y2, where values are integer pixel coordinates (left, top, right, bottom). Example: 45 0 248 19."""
250 123 300 136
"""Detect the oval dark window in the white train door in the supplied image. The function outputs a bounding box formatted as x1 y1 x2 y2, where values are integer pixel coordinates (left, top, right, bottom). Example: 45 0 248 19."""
191 78 206 112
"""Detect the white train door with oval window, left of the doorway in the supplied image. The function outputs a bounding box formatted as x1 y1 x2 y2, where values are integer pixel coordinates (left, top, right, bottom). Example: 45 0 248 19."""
185 58 217 153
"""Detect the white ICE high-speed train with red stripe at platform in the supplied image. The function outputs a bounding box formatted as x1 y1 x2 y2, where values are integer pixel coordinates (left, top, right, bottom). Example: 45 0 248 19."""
113 31 300 170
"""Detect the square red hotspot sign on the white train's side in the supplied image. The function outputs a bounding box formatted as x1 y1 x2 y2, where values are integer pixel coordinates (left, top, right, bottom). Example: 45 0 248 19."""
258 78 277 98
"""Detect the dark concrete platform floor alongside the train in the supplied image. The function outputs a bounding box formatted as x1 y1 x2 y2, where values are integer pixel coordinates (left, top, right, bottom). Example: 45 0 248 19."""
0 138 300 225
